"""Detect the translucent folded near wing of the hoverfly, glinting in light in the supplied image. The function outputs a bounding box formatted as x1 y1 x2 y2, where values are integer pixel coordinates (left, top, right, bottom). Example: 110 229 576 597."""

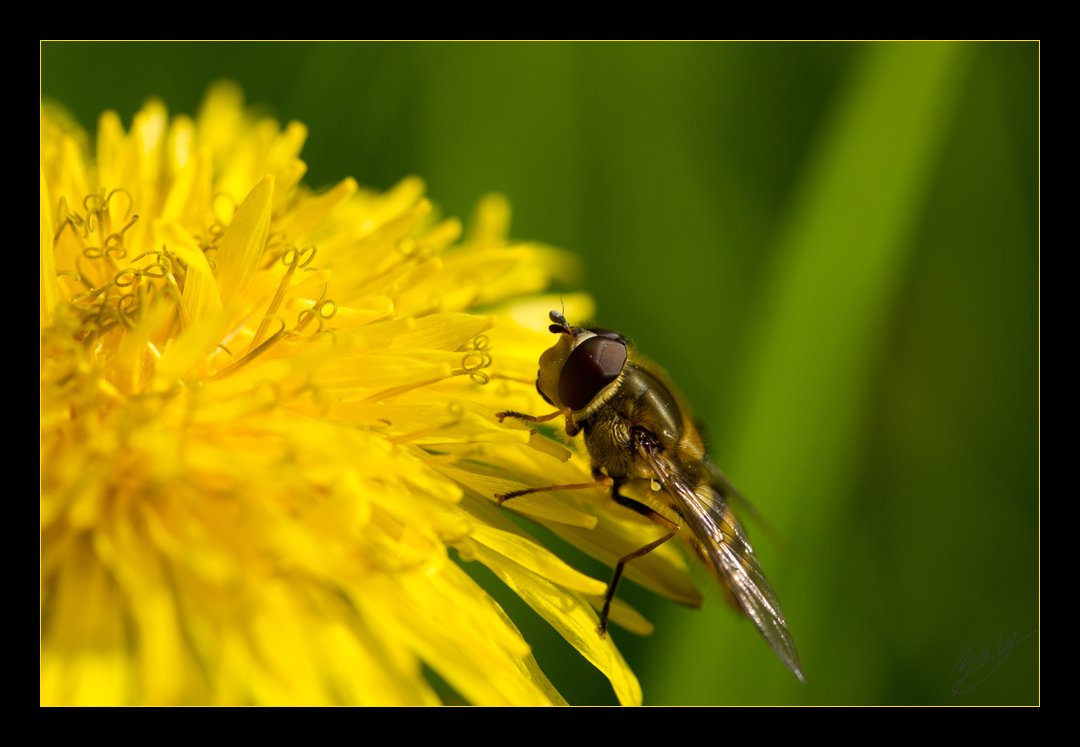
637 443 806 682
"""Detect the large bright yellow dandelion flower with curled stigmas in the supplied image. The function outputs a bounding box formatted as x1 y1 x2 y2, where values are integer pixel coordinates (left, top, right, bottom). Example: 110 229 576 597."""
40 84 700 705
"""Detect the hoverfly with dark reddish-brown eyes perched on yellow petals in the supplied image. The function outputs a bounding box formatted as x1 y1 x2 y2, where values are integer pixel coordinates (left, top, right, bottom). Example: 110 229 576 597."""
496 311 806 682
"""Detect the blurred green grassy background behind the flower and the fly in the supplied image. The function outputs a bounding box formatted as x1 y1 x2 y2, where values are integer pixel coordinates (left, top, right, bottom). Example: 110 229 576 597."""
41 42 1040 705
